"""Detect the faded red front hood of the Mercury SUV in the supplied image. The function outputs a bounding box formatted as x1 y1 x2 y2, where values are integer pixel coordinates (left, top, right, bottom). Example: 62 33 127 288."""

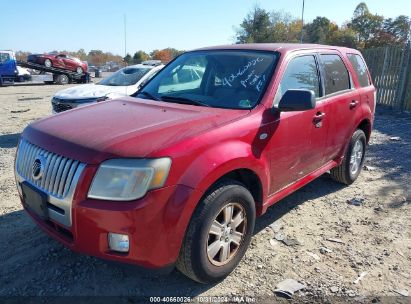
23 97 249 164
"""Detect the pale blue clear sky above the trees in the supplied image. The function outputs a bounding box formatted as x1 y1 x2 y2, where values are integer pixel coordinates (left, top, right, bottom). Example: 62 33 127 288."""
0 0 411 55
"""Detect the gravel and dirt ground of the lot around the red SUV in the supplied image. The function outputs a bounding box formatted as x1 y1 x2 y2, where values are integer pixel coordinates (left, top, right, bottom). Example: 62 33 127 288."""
0 85 411 299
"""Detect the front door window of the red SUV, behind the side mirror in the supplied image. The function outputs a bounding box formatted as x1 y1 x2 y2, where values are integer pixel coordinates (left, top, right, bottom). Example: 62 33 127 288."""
274 55 320 105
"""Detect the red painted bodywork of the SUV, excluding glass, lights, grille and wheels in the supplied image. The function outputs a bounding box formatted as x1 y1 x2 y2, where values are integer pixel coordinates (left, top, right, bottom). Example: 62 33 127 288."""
18 44 375 268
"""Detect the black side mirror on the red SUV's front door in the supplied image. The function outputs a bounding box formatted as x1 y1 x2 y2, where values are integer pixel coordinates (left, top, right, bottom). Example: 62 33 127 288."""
278 89 315 112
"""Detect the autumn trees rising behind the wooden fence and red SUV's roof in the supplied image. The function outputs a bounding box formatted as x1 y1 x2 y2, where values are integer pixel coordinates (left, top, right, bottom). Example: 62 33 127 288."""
236 2 411 49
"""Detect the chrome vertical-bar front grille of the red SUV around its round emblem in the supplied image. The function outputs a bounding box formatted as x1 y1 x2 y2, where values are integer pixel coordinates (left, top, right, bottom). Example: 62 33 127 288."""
16 139 84 199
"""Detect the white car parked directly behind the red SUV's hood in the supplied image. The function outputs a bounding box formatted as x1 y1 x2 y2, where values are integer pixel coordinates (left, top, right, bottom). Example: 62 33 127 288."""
51 60 164 114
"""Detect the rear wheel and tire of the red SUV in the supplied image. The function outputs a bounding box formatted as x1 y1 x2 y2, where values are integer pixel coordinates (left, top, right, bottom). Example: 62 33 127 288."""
331 129 367 185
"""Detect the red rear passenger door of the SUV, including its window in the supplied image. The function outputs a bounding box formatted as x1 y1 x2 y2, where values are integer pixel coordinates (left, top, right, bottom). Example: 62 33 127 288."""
319 51 361 162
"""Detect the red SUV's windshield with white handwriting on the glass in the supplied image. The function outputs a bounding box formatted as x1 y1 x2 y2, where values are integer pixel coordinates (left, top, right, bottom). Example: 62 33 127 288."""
137 50 278 109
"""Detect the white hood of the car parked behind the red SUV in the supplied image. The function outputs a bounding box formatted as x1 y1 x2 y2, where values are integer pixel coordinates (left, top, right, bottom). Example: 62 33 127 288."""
54 84 130 99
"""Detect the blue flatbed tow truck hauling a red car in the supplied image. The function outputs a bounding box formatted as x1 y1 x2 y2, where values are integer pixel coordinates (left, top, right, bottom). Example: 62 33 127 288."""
0 51 90 86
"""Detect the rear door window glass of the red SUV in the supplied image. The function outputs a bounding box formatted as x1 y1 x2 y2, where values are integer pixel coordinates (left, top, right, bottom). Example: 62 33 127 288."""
320 54 350 95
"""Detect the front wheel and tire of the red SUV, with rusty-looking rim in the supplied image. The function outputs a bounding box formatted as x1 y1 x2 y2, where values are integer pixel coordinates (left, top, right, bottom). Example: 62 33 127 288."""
176 180 256 283
